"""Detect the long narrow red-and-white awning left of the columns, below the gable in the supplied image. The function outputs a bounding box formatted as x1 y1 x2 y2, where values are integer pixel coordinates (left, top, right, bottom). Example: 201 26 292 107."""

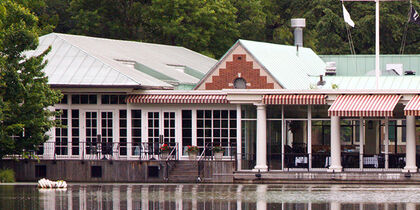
126 94 229 104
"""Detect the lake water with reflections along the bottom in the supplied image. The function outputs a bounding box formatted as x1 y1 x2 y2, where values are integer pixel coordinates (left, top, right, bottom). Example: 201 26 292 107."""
0 183 420 210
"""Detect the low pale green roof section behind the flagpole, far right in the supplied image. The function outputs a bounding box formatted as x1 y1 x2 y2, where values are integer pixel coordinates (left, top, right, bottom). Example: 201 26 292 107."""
319 54 420 76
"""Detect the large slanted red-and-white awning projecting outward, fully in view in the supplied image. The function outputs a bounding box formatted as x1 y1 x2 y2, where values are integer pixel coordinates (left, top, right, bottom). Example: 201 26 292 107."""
328 95 401 117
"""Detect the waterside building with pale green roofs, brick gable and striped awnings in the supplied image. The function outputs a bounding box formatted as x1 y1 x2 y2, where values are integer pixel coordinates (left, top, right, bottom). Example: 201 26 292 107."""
7 33 420 181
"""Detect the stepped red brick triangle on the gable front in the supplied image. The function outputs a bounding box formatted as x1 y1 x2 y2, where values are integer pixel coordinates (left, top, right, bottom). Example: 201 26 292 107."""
205 54 274 90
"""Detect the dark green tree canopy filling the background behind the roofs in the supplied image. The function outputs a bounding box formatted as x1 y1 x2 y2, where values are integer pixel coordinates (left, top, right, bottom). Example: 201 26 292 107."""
31 0 420 58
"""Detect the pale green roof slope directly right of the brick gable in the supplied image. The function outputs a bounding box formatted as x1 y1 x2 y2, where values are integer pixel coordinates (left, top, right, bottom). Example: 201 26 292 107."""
239 40 325 89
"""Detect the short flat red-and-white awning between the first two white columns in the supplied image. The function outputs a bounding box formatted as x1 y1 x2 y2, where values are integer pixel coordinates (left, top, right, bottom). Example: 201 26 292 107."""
263 95 326 105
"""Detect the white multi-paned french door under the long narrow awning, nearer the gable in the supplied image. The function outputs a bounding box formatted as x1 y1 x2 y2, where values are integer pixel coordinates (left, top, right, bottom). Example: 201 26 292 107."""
146 110 177 154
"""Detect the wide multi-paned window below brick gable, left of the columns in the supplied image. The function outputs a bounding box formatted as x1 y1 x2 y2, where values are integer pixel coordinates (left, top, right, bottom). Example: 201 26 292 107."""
197 110 236 155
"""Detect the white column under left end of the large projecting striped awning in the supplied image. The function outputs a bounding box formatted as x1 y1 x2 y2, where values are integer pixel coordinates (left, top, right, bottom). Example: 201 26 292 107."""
328 116 343 172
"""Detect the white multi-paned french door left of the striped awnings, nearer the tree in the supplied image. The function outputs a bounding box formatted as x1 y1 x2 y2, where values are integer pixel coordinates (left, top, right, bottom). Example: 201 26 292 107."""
85 111 114 155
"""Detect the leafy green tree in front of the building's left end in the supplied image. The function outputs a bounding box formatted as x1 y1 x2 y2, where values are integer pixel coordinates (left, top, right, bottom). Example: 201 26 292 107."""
0 0 61 158
